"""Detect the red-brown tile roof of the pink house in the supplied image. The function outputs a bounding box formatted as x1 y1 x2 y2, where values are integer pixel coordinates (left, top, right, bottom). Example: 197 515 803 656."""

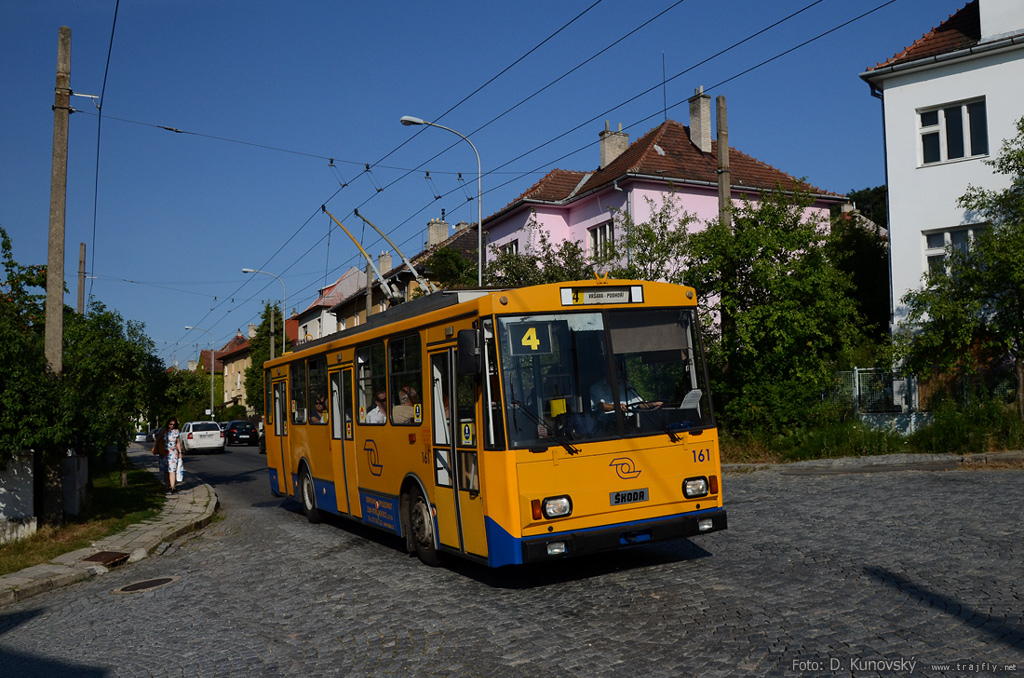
502 120 842 212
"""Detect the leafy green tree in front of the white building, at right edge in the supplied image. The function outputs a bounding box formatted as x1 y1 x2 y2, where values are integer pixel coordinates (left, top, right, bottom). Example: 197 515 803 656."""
896 118 1024 418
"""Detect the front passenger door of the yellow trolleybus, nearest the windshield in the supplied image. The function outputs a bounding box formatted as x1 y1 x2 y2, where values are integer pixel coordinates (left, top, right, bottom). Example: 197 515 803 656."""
430 349 487 557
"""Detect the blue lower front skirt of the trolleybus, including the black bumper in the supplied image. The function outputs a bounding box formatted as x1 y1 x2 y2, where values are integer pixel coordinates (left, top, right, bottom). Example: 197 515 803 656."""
486 508 728 567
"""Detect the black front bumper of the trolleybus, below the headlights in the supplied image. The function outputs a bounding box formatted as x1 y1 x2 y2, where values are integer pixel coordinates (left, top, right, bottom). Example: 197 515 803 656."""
521 508 728 563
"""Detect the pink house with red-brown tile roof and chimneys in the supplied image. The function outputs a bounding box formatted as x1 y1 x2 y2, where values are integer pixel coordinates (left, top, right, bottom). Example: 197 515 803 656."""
483 93 846 256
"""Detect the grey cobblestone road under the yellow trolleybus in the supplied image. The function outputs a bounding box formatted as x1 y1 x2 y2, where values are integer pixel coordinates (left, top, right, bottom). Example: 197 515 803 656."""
0 462 1024 678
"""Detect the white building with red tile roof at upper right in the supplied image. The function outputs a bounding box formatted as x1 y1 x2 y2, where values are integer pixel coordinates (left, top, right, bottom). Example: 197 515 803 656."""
860 0 1024 328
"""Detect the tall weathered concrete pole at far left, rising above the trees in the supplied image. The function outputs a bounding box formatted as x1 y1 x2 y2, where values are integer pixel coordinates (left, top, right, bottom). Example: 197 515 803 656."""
43 26 71 374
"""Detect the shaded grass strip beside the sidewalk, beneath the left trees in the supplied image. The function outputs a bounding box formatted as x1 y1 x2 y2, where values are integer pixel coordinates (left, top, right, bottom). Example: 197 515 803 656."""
0 468 167 576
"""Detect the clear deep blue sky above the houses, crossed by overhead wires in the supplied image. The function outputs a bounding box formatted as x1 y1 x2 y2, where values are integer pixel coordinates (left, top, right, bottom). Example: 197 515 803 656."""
0 0 967 365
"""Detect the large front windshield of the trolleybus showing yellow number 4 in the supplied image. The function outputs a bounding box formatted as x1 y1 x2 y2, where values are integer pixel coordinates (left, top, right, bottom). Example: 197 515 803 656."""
498 308 715 453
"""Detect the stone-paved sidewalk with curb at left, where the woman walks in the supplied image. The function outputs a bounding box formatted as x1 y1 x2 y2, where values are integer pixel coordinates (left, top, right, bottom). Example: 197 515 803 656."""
0 446 217 607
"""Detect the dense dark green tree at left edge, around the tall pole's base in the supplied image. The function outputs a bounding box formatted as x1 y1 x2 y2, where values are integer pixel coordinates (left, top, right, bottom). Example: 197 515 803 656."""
0 228 160 522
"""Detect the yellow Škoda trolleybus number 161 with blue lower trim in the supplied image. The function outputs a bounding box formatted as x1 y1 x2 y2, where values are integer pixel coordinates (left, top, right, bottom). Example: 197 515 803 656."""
264 279 726 567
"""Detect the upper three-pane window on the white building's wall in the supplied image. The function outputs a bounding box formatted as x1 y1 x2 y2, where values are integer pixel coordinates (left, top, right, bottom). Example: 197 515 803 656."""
918 99 988 165
